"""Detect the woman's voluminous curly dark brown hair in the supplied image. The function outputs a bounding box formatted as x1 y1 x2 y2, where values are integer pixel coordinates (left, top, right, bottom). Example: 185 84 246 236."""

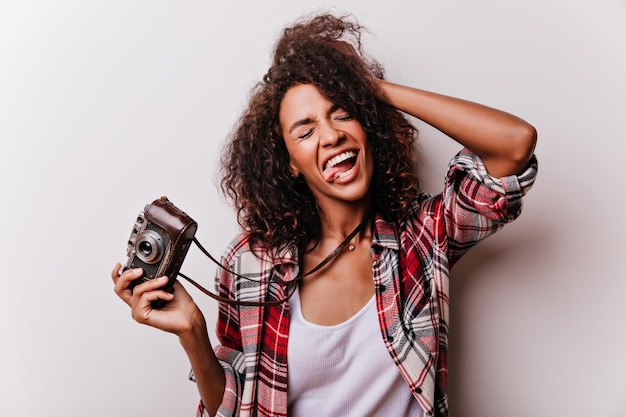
221 14 419 250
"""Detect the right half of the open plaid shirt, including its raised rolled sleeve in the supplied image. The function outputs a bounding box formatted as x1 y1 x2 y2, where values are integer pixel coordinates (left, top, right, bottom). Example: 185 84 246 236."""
374 149 537 417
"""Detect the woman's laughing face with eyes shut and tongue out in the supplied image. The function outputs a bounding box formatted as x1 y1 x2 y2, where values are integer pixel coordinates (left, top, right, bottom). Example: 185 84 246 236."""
279 84 374 207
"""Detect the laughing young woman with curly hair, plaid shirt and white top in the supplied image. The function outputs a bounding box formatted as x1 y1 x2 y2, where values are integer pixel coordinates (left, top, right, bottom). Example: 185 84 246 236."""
112 15 537 416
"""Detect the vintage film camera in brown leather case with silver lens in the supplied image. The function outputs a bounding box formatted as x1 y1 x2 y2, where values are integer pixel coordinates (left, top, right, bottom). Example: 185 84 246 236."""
124 197 198 296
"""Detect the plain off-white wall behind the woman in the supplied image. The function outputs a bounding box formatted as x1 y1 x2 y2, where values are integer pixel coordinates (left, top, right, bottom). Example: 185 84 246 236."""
0 0 626 417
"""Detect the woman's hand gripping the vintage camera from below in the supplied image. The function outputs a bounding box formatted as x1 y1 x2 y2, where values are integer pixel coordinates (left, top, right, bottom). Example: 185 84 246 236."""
111 263 204 337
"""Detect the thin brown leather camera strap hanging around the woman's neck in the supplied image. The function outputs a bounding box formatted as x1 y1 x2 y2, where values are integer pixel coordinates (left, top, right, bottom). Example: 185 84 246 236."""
178 215 371 306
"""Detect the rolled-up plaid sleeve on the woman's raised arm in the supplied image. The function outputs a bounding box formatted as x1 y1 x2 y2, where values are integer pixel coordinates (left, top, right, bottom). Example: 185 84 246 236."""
443 149 537 265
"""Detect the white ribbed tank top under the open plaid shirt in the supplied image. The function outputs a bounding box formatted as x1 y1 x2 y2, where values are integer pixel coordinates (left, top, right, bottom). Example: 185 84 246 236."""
287 290 422 417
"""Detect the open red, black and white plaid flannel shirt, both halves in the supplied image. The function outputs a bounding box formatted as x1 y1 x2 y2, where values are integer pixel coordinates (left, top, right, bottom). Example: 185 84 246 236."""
198 150 537 417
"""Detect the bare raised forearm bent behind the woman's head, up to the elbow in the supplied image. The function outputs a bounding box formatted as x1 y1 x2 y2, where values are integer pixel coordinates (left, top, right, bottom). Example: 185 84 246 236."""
379 81 537 177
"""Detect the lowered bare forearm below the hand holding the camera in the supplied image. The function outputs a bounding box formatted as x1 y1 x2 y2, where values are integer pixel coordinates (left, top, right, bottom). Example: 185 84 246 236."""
179 317 226 415
